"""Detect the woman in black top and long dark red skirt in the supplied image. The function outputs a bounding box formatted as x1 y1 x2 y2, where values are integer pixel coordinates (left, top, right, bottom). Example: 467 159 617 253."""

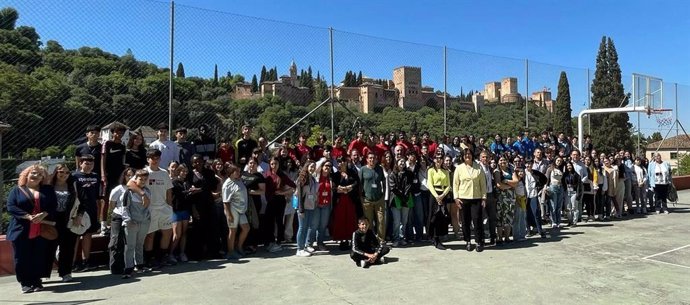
324 157 359 250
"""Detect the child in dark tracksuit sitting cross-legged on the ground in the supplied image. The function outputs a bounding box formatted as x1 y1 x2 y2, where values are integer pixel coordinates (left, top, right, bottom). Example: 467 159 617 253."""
350 217 391 268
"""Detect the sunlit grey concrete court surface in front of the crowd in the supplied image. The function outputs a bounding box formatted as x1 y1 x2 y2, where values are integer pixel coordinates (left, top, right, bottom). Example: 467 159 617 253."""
0 191 690 304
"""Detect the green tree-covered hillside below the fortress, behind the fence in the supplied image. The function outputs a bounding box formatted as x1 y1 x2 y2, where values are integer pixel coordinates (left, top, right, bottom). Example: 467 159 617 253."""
0 8 552 164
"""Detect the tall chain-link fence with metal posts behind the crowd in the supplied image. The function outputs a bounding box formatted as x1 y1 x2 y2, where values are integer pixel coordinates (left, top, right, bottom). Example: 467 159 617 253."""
0 0 690 226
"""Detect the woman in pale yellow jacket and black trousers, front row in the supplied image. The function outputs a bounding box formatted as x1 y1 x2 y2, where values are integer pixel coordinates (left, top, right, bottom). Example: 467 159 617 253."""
453 148 486 252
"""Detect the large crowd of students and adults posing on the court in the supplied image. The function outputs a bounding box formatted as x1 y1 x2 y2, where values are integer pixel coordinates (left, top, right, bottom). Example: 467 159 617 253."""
7 124 673 293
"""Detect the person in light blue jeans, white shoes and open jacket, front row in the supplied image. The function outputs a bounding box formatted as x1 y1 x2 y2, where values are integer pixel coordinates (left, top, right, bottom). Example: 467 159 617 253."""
295 161 319 257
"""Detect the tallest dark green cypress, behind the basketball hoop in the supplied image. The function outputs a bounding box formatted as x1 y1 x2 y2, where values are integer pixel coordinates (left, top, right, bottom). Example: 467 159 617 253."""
591 36 632 152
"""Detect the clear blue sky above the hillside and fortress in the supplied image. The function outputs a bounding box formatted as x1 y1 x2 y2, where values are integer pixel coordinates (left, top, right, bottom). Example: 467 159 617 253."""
3 0 690 134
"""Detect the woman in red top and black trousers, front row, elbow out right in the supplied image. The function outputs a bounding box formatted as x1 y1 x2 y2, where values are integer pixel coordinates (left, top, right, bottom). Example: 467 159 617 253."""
262 157 295 252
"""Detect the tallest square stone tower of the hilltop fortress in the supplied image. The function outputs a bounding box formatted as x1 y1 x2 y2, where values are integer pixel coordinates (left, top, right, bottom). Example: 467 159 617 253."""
393 66 423 109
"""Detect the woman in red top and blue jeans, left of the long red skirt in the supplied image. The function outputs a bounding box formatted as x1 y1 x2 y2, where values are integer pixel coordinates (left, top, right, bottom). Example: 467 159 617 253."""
311 160 335 251
